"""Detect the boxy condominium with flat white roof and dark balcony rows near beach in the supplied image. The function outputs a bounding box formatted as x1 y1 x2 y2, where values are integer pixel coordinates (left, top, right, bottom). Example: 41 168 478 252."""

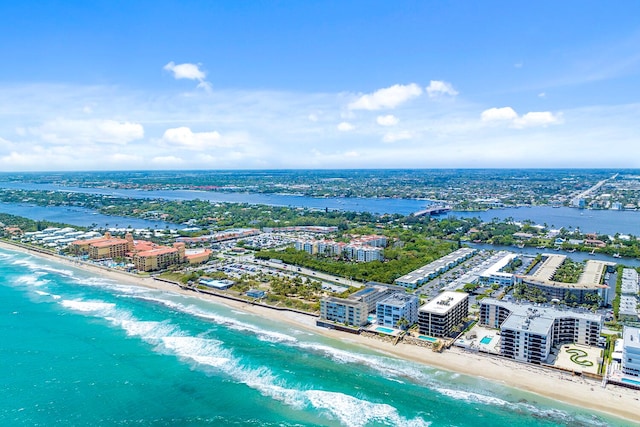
418 291 469 337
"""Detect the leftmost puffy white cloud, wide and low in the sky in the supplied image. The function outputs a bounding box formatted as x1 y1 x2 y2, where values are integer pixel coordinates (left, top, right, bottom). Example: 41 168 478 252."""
29 118 144 145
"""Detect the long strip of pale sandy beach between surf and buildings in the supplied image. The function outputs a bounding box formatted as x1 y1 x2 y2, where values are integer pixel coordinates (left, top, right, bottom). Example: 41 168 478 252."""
0 241 640 423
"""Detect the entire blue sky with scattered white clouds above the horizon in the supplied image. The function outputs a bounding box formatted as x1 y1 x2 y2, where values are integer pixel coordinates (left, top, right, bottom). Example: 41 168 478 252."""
0 0 640 171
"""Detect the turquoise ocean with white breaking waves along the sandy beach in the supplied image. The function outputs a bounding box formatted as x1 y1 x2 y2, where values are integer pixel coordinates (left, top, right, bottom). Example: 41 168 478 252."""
0 251 628 427
